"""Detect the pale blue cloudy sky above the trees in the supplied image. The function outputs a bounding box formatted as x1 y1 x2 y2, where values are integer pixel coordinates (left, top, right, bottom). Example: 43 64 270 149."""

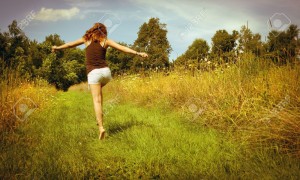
0 0 300 60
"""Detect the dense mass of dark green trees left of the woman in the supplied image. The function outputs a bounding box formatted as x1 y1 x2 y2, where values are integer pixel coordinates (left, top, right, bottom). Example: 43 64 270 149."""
0 21 86 91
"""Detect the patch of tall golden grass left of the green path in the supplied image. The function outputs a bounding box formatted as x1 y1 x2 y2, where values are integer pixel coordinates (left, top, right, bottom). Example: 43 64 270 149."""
0 68 56 132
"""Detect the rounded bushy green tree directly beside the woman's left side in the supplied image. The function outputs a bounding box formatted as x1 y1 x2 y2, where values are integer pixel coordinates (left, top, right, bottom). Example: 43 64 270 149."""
37 34 86 91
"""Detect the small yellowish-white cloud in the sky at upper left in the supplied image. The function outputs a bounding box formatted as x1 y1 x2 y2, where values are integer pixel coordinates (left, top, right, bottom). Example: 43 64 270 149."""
35 7 80 21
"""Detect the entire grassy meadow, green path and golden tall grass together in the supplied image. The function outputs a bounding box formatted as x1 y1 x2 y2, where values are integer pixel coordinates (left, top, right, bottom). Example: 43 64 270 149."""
0 56 300 179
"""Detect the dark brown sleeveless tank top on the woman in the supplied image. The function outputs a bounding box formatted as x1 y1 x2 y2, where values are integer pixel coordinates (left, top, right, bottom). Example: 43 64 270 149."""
85 41 108 73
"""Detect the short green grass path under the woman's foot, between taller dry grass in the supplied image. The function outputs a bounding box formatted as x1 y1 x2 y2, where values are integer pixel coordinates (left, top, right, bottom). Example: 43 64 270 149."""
0 91 300 179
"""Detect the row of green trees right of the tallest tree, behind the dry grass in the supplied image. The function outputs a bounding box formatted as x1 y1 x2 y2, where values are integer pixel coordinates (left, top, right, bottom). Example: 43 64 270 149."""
174 24 300 69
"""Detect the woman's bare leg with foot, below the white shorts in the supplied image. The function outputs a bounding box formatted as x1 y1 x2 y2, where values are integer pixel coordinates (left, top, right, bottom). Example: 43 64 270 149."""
90 84 105 139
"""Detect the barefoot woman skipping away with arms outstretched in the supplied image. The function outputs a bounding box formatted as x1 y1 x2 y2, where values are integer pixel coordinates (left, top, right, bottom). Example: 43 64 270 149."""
52 23 148 140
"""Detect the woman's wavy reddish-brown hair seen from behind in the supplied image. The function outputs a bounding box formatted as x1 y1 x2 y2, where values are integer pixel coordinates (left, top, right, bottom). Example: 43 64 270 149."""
83 23 107 42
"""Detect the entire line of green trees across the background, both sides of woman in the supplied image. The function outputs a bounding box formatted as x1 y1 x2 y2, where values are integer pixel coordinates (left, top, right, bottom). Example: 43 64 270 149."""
0 18 299 90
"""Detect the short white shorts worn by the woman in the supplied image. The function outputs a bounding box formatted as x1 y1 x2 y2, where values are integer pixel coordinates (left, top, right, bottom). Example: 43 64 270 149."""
87 67 112 86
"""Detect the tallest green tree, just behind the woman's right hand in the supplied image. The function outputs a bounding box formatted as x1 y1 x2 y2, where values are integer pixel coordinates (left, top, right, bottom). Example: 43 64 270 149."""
132 18 172 71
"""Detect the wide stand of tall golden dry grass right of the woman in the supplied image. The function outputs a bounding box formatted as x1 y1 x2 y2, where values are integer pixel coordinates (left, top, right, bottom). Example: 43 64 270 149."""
105 55 300 157
